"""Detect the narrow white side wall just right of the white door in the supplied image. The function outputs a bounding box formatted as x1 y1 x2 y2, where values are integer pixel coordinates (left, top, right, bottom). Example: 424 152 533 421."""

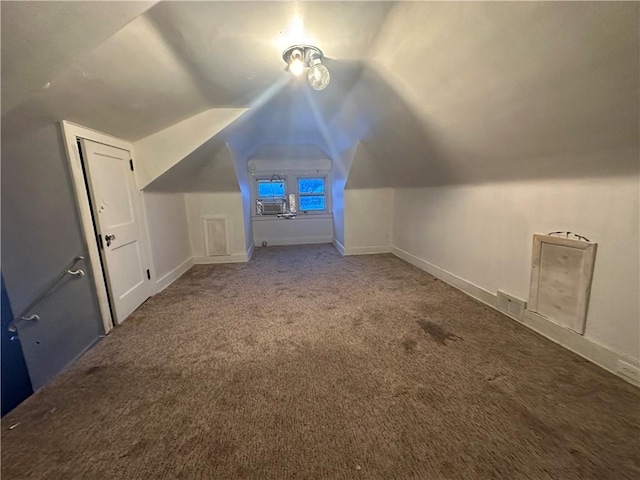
143 192 192 291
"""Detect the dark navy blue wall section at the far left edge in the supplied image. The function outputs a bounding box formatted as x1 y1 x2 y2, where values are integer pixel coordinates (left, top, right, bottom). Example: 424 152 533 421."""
1 277 33 416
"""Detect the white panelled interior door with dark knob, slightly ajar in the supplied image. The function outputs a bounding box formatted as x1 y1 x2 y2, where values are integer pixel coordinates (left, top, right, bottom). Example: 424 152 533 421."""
81 139 152 323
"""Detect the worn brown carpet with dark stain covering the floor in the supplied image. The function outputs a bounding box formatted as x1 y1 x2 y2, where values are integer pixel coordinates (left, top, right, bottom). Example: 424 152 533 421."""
2 245 640 480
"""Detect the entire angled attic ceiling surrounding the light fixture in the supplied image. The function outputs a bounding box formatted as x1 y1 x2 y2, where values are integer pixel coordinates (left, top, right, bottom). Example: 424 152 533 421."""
1 2 640 188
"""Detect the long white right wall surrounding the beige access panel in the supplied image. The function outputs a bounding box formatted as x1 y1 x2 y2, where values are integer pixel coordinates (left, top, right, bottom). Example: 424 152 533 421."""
390 175 640 362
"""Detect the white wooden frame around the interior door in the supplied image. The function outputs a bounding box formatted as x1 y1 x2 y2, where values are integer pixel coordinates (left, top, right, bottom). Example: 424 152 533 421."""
60 120 156 334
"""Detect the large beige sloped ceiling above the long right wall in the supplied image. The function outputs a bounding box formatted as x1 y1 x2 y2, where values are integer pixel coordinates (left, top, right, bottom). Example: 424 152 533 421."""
368 2 640 184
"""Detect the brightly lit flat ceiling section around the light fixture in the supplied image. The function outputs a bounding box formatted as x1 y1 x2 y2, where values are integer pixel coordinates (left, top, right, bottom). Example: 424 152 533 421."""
147 2 390 107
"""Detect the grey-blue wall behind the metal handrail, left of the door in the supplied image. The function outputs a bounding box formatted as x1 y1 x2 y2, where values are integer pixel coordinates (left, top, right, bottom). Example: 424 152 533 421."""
0 122 104 390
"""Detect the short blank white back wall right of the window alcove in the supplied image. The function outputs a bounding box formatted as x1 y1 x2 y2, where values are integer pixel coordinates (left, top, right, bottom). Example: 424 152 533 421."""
344 188 394 255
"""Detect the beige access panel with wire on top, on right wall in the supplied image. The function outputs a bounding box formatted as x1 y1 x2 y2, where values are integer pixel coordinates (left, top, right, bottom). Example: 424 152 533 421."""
529 235 597 335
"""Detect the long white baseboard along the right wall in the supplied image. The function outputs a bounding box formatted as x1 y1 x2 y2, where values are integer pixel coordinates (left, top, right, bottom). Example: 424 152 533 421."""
391 246 640 386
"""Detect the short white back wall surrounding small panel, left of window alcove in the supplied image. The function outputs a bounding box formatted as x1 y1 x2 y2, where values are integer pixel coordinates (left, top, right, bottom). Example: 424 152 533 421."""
185 192 247 263
